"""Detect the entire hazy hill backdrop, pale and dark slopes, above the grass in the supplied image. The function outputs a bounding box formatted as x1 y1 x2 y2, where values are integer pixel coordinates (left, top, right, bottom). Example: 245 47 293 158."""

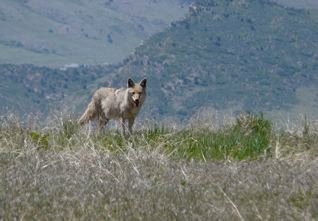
0 0 318 119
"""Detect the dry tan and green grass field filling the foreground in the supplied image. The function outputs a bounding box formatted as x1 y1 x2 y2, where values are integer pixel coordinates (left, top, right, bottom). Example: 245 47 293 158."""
0 116 318 220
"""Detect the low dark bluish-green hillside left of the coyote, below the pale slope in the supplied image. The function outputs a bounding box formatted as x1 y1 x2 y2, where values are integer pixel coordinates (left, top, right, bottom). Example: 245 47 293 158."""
0 64 118 115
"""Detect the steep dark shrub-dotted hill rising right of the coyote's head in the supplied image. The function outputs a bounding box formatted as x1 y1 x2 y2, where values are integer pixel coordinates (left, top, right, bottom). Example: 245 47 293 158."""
105 0 318 118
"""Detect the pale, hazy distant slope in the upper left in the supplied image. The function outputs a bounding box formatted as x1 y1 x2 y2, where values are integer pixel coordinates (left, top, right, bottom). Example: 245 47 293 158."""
0 0 187 66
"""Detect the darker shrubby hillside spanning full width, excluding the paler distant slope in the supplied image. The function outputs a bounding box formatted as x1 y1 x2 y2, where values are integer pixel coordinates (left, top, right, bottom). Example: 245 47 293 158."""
0 0 318 119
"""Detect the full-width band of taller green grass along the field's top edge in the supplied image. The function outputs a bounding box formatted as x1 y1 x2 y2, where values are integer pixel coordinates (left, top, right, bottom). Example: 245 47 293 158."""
6 115 318 161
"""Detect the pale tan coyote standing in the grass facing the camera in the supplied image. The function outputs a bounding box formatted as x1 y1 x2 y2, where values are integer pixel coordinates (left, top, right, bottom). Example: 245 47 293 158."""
78 78 147 135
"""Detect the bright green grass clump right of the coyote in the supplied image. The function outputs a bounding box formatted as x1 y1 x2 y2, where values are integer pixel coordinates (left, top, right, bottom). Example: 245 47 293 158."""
167 116 272 160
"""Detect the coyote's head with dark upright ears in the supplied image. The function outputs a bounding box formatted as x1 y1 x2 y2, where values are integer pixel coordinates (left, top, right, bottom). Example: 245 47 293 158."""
128 78 147 107
